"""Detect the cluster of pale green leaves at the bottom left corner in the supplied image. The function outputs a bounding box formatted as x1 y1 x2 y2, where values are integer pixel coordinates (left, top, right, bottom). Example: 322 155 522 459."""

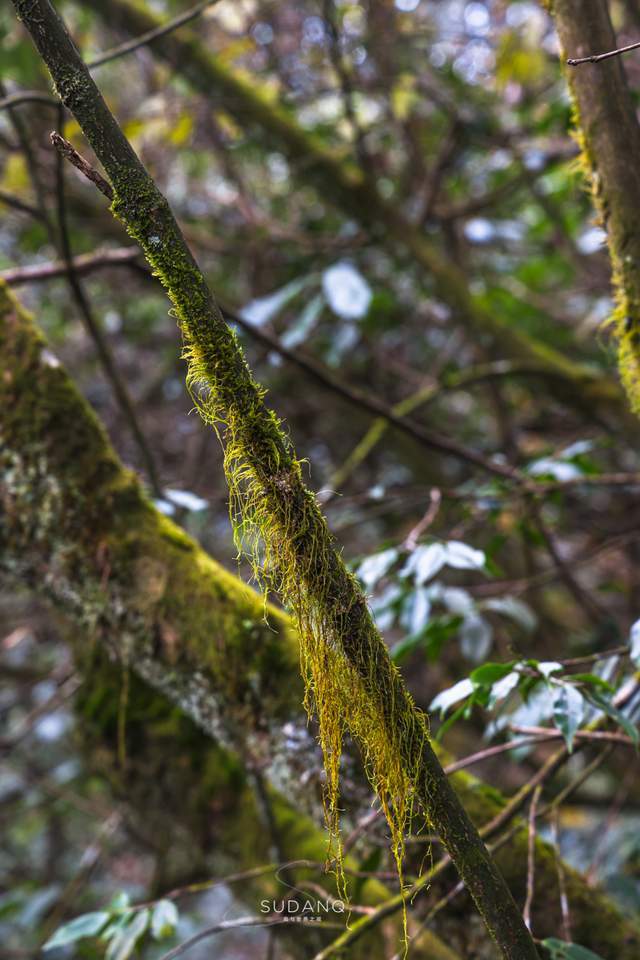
42 893 178 960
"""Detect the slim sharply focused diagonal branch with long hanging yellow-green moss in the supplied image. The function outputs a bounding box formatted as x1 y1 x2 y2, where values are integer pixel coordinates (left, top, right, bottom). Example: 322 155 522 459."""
14 0 538 960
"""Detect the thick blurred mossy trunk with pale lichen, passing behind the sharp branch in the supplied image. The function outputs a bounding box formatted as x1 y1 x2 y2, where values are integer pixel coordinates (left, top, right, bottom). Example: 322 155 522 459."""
0 284 640 960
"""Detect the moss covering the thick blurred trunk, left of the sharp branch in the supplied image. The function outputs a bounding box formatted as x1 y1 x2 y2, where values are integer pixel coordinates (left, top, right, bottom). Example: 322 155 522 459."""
0 284 301 723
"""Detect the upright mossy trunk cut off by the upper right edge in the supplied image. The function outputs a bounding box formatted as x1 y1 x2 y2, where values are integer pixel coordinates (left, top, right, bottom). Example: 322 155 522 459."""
546 0 640 414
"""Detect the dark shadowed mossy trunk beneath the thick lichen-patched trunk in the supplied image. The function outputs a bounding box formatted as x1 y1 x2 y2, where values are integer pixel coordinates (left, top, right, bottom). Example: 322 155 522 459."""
68 652 460 960
